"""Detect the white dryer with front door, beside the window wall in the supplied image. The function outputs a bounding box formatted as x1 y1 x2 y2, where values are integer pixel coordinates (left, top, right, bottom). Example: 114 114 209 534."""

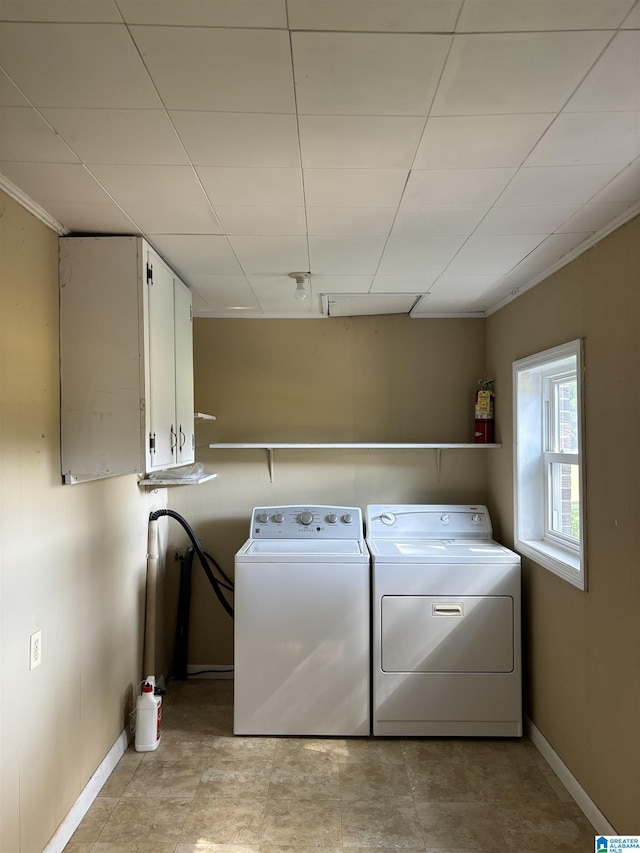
366 504 522 737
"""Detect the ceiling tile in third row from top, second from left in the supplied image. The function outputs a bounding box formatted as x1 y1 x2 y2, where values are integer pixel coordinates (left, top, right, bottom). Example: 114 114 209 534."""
42 109 189 165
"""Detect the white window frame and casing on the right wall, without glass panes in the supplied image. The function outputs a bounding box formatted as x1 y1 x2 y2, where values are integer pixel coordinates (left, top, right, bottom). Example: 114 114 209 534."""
513 339 587 590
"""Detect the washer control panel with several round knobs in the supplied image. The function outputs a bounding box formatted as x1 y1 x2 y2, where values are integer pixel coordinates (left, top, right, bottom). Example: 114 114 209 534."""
250 504 364 539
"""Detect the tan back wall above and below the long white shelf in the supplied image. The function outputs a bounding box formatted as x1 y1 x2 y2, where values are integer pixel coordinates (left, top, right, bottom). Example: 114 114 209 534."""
168 315 488 665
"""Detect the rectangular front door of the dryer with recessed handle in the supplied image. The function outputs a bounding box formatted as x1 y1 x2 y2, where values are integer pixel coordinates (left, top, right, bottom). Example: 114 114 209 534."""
381 595 514 672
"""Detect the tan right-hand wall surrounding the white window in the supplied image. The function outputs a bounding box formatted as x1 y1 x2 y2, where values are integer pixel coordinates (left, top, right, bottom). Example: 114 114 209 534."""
487 219 640 833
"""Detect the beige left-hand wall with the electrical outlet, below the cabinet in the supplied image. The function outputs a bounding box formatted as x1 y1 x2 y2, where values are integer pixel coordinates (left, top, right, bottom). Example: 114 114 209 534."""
0 193 166 853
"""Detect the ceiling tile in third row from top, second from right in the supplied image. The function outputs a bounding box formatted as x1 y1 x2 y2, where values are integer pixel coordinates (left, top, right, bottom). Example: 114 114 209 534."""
413 113 555 169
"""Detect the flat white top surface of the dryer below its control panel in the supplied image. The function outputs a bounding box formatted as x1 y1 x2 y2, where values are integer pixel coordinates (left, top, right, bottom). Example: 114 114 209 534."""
367 539 520 564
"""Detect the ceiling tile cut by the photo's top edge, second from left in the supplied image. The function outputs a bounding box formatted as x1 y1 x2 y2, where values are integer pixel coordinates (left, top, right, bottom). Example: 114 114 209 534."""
117 0 287 28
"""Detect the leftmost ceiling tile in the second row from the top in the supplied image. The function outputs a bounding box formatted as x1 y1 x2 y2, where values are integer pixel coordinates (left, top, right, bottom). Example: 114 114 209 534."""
0 23 161 109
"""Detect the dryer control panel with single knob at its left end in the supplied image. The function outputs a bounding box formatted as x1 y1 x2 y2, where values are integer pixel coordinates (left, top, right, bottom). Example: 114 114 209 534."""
366 504 493 540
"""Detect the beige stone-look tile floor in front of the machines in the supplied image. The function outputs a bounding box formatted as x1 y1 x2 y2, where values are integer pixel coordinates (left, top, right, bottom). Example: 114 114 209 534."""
65 679 595 853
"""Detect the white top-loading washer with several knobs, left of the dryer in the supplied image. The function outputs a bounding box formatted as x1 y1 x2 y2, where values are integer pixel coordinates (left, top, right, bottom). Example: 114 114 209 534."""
233 506 370 736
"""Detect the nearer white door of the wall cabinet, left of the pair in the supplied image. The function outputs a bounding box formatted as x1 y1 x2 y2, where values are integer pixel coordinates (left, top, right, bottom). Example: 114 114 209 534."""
145 251 177 471
